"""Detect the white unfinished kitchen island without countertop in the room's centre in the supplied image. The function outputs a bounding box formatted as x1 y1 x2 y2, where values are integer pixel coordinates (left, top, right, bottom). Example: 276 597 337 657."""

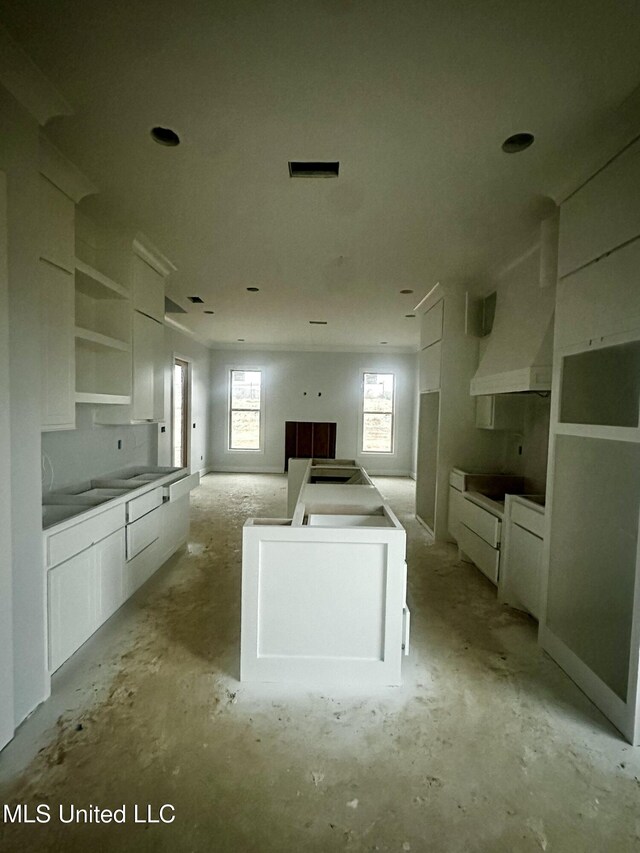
240 459 409 686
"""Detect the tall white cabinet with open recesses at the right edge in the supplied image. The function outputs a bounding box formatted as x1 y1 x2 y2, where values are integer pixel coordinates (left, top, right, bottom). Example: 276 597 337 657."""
540 136 640 744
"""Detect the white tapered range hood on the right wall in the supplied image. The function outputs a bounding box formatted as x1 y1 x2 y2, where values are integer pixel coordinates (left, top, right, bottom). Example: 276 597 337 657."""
471 230 555 396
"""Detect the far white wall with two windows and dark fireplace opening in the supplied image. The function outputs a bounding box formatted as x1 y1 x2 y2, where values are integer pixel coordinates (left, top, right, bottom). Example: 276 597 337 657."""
210 350 416 474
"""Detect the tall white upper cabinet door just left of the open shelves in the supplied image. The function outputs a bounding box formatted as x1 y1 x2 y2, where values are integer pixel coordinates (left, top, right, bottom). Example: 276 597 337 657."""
39 260 75 430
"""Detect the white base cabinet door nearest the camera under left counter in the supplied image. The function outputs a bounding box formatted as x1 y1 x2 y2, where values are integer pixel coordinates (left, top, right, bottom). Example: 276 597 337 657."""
48 547 98 672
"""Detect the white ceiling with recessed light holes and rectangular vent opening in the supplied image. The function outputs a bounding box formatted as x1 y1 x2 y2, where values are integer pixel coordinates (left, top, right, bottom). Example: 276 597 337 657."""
0 0 640 349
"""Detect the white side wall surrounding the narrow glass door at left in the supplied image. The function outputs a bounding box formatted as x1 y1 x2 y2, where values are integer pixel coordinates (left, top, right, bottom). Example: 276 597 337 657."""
157 326 211 472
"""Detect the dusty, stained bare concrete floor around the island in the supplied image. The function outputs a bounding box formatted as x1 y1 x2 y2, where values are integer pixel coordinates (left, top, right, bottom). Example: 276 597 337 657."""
0 474 640 853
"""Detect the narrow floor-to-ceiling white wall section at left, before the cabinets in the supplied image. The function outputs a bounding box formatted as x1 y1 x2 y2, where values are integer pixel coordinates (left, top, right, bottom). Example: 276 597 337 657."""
0 87 49 725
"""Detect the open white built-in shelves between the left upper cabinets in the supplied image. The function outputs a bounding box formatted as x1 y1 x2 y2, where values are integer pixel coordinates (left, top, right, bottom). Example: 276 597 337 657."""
74 258 131 405
